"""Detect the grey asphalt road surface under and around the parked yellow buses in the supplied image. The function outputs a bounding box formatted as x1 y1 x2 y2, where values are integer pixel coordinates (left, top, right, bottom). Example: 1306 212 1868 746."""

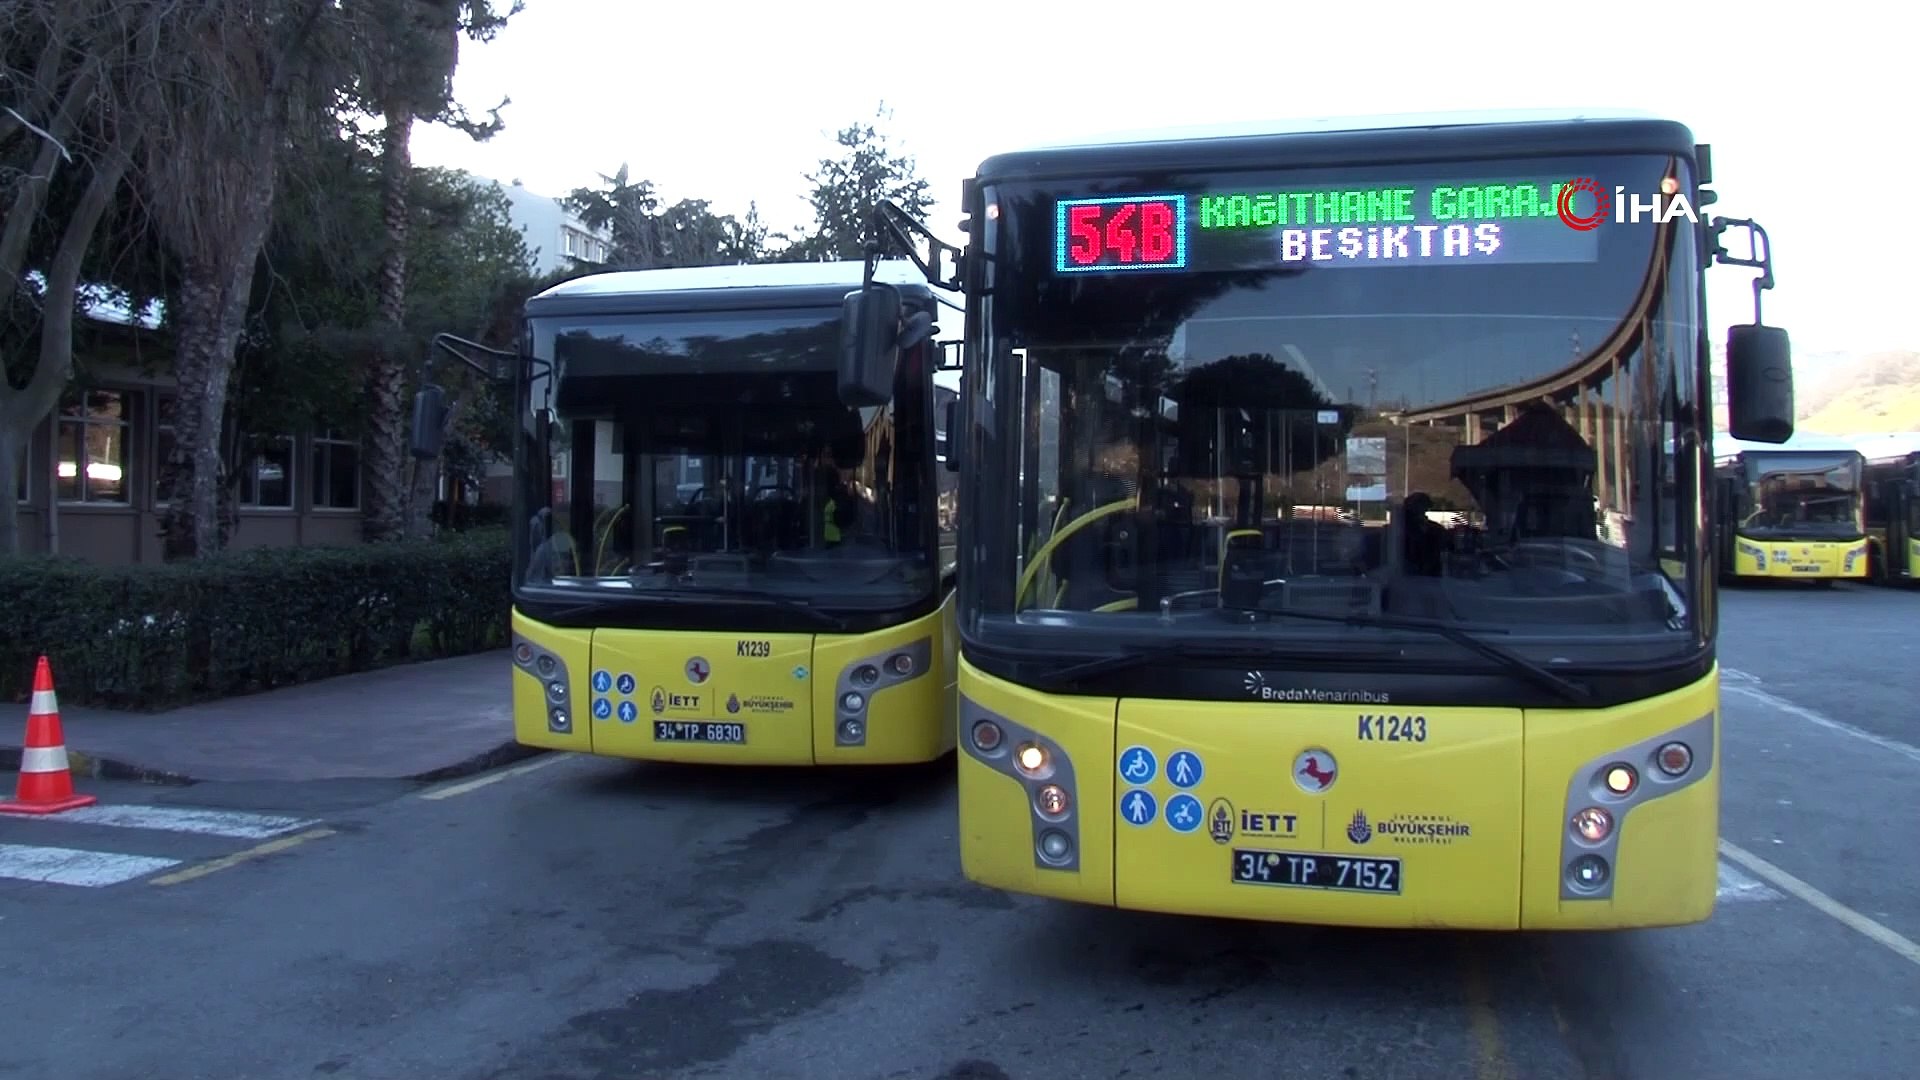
0 588 1920 1080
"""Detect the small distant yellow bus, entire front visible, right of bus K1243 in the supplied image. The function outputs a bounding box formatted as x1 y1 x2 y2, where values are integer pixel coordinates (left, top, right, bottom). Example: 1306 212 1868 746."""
1715 446 1868 586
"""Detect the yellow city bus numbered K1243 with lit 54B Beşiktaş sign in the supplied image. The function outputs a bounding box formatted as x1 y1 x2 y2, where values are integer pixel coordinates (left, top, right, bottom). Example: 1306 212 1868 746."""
848 109 1793 930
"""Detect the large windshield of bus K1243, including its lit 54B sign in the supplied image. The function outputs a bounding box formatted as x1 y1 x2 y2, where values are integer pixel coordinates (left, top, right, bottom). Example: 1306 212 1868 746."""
960 147 1709 661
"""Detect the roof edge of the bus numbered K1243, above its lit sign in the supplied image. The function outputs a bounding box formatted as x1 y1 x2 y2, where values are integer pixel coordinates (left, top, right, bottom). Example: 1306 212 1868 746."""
973 108 1695 183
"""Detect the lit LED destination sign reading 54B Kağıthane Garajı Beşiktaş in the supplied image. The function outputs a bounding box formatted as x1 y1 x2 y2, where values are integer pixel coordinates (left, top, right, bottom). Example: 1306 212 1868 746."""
1054 179 1599 273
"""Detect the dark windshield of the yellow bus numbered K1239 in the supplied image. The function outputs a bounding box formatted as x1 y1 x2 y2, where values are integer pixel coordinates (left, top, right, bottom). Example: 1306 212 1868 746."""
515 307 935 611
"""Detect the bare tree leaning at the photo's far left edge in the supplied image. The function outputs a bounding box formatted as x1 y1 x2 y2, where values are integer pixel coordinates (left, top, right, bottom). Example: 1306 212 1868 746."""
0 0 168 553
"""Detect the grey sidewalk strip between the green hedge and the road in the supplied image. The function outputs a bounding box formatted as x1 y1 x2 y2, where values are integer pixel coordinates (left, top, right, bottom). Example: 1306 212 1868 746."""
0 650 538 788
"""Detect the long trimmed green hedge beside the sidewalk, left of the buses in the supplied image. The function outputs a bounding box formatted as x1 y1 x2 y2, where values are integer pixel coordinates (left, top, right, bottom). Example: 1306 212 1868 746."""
0 530 511 709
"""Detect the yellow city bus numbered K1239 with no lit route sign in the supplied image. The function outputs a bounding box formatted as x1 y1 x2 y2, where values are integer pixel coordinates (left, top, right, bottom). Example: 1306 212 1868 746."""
415 263 958 765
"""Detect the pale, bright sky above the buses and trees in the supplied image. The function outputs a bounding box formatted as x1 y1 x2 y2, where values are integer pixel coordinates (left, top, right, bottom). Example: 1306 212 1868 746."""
413 0 1920 357
